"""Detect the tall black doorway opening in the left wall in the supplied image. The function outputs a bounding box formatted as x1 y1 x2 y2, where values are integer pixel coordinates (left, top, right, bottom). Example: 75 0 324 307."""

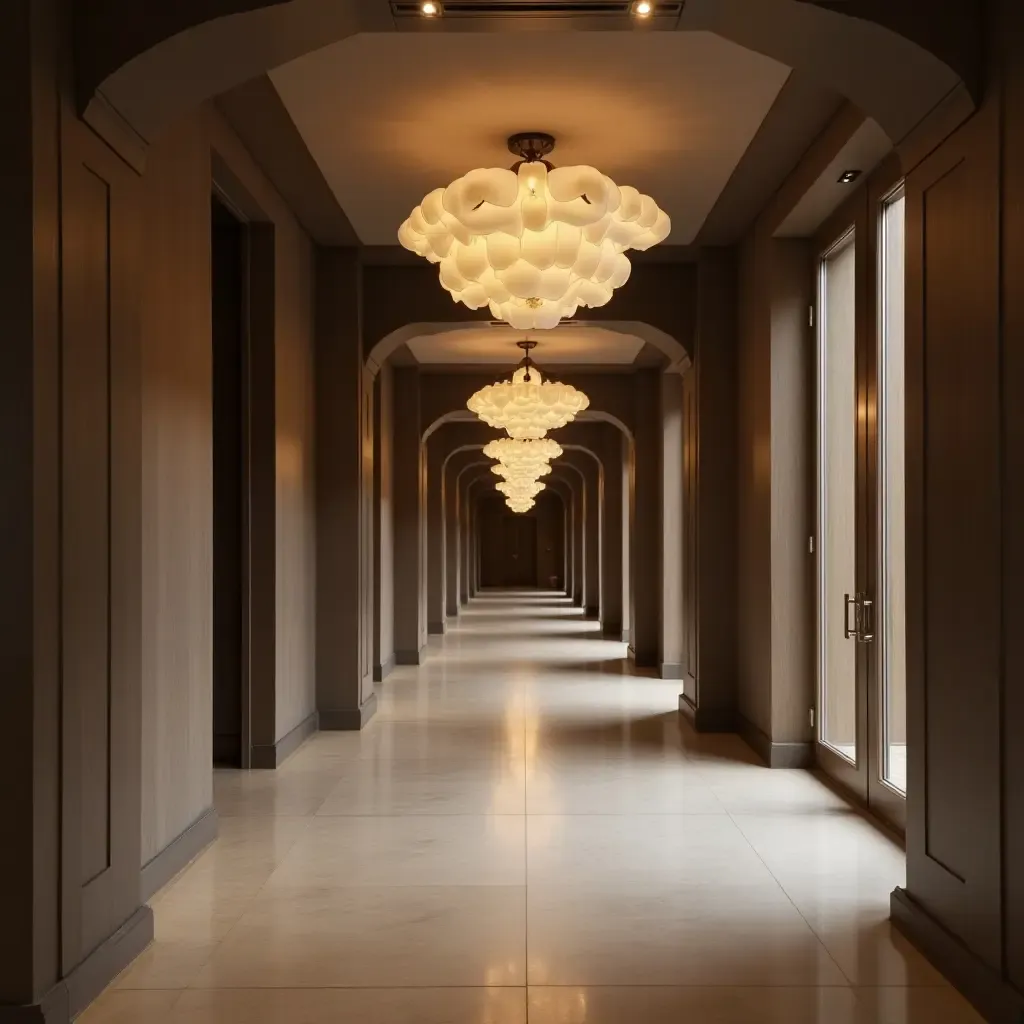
210 195 248 768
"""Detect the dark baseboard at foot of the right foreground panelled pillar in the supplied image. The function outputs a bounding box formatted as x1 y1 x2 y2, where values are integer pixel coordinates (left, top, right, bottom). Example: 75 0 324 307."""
889 888 1024 1024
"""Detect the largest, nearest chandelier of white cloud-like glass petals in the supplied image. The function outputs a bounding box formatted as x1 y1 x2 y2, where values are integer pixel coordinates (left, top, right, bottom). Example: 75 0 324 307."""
398 132 672 331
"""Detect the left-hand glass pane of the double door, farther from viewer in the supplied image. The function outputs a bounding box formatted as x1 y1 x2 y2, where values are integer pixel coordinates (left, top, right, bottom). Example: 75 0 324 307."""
817 231 857 764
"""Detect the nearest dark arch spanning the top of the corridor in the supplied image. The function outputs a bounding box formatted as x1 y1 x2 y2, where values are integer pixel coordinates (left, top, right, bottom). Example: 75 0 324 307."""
81 0 983 167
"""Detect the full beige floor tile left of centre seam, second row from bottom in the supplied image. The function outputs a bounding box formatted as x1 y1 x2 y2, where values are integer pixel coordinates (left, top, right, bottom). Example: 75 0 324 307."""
196 886 525 988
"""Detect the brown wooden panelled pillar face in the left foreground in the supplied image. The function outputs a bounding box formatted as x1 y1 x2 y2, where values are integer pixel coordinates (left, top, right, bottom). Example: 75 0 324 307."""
60 112 141 971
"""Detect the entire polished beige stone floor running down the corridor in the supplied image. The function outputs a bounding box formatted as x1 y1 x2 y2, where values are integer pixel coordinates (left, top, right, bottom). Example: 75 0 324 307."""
84 594 980 1024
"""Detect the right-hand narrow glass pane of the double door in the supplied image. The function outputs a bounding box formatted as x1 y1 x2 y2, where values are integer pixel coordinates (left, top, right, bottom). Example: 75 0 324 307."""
879 186 906 793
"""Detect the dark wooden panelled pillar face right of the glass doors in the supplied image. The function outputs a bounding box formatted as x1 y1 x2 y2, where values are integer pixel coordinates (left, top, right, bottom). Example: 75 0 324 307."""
907 105 1001 970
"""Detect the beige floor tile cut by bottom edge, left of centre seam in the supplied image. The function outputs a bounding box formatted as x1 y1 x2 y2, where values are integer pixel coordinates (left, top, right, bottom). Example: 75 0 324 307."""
165 988 526 1024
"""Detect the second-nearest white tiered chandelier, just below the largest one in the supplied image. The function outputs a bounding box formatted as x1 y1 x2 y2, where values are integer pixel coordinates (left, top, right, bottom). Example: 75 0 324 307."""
466 341 590 439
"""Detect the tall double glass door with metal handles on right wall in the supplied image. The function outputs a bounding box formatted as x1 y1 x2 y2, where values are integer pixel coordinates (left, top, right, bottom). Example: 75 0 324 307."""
814 189 906 828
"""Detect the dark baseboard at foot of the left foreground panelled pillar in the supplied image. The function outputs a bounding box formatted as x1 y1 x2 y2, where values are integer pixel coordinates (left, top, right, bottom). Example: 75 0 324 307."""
0 906 153 1024
